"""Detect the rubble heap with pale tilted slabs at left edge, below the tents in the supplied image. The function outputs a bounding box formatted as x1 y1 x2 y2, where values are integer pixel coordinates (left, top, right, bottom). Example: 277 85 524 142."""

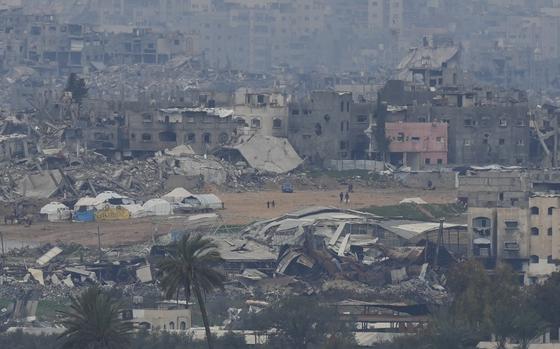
0 244 159 301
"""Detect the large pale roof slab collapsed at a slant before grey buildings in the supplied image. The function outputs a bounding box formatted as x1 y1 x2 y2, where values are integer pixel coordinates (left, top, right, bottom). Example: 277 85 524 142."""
224 135 303 173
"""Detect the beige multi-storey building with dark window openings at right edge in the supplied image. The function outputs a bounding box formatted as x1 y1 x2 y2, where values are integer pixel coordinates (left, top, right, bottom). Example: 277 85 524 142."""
468 193 560 284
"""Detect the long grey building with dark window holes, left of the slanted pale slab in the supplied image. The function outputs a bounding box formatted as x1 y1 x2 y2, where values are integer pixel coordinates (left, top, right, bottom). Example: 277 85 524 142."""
125 108 243 154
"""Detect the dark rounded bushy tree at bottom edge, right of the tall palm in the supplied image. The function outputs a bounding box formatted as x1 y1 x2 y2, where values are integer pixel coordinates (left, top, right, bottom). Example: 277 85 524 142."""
255 296 355 349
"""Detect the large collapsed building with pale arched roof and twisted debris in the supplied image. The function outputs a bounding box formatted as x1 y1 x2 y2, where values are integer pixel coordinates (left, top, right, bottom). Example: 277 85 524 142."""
219 207 468 285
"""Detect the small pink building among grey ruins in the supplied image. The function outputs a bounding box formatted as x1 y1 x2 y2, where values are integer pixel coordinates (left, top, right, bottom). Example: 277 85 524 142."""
385 122 448 170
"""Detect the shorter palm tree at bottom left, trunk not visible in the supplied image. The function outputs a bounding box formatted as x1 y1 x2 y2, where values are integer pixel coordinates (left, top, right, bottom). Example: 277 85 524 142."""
59 286 132 349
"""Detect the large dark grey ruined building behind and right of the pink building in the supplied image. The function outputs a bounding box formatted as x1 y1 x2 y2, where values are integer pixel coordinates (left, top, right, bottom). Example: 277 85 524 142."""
371 82 531 165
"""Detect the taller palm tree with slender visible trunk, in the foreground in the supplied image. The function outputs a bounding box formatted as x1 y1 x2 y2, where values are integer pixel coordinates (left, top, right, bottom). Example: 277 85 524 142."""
159 234 225 349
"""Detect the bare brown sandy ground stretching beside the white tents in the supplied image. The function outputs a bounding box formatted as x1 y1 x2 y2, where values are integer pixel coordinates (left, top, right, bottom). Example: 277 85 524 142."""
0 187 456 247
